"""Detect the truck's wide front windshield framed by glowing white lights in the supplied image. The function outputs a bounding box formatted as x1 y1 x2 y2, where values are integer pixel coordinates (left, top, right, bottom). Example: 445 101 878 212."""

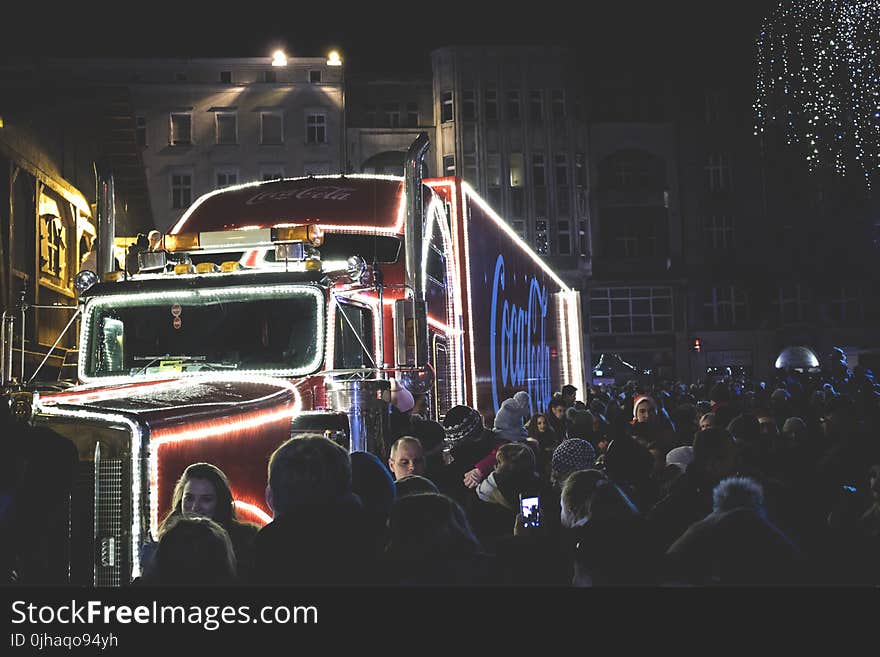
83 285 324 378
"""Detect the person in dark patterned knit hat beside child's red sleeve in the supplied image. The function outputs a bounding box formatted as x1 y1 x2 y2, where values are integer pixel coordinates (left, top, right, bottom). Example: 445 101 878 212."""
444 405 507 500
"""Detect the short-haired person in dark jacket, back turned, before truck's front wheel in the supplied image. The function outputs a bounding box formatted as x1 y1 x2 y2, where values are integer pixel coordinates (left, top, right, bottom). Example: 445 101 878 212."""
251 434 377 586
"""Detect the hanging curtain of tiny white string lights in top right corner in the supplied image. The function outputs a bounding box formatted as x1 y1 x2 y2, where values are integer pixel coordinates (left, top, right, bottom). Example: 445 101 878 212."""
754 0 880 188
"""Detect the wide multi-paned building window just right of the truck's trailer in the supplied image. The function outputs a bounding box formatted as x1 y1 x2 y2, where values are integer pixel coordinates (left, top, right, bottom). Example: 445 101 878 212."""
590 287 673 334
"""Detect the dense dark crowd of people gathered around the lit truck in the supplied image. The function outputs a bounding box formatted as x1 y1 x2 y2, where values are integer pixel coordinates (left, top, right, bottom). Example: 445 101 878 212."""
134 346 880 586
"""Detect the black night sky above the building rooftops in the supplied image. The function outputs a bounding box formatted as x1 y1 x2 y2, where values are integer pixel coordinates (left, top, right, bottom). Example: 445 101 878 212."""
0 0 778 77
